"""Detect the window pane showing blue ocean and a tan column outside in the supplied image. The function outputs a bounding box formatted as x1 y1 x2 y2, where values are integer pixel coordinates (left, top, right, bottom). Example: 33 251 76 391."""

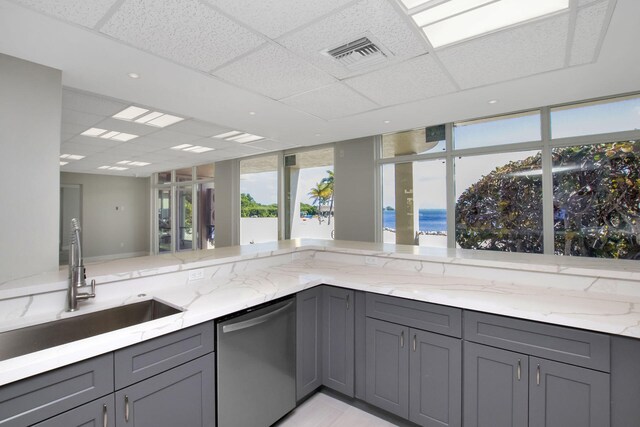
382 159 447 248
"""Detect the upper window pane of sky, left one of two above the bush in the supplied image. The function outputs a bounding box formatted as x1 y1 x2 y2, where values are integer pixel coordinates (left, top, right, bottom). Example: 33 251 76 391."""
453 111 541 149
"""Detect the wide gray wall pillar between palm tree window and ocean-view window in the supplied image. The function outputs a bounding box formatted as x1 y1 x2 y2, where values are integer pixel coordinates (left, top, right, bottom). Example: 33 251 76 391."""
334 137 376 242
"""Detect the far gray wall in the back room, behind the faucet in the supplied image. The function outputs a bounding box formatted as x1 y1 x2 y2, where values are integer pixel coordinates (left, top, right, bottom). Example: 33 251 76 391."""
60 172 151 261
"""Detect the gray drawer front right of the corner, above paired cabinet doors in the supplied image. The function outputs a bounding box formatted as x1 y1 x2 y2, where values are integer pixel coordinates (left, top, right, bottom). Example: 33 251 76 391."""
366 293 462 338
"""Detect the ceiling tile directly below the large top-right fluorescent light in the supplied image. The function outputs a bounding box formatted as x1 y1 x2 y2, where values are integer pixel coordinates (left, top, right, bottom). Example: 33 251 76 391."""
437 13 569 89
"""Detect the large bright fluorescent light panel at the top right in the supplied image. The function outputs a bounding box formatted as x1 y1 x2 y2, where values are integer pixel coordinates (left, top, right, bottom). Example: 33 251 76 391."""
412 0 569 48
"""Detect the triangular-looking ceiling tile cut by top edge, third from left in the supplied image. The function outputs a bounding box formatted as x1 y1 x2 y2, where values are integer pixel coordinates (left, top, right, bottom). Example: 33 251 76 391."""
207 0 353 39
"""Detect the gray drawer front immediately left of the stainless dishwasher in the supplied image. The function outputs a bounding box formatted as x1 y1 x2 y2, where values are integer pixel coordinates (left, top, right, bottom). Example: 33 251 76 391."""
115 322 213 390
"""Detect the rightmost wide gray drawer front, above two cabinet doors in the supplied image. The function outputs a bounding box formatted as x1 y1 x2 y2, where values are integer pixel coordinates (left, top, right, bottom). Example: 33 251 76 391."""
464 311 611 372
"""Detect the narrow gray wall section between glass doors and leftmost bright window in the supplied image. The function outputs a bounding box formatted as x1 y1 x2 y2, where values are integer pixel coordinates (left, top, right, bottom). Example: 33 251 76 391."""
215 160 240 248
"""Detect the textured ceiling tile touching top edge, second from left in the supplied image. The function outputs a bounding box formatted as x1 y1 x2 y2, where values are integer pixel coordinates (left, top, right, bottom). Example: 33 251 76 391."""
101 0 264 72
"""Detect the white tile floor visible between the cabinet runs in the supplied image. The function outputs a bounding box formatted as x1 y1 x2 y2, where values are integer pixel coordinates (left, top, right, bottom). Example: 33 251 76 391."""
275 393 395 427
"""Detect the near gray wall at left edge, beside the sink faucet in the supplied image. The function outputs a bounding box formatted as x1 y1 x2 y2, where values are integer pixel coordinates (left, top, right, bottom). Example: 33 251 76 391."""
0 54 62 283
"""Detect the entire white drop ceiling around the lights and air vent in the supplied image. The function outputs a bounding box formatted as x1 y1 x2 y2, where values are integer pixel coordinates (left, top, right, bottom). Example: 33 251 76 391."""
0 0 640 176
